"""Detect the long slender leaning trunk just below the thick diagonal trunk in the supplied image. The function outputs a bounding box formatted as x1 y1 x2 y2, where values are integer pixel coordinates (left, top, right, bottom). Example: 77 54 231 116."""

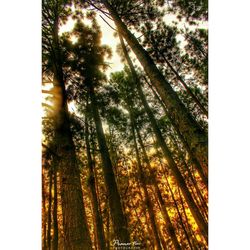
118 32 208 239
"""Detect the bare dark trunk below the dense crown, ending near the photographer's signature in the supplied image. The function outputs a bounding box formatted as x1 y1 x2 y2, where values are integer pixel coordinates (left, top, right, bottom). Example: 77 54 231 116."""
89 84 130 243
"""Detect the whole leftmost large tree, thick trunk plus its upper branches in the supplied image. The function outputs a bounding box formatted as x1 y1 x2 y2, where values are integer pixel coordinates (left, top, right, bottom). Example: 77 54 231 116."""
42 0 91 249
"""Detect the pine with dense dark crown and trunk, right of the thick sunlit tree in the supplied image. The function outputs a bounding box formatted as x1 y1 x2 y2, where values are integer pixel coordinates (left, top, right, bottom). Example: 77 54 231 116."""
60 20 130 242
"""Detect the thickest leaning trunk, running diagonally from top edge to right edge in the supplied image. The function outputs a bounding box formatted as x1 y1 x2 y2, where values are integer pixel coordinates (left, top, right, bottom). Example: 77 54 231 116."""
101 0 208 170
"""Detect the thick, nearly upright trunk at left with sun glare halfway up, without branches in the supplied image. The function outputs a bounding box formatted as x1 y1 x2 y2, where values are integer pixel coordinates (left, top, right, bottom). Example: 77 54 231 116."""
52 14 91 250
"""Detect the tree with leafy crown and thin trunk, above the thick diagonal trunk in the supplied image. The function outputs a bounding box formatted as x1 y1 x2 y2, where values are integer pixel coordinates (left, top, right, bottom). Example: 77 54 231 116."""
141 21 208 117
